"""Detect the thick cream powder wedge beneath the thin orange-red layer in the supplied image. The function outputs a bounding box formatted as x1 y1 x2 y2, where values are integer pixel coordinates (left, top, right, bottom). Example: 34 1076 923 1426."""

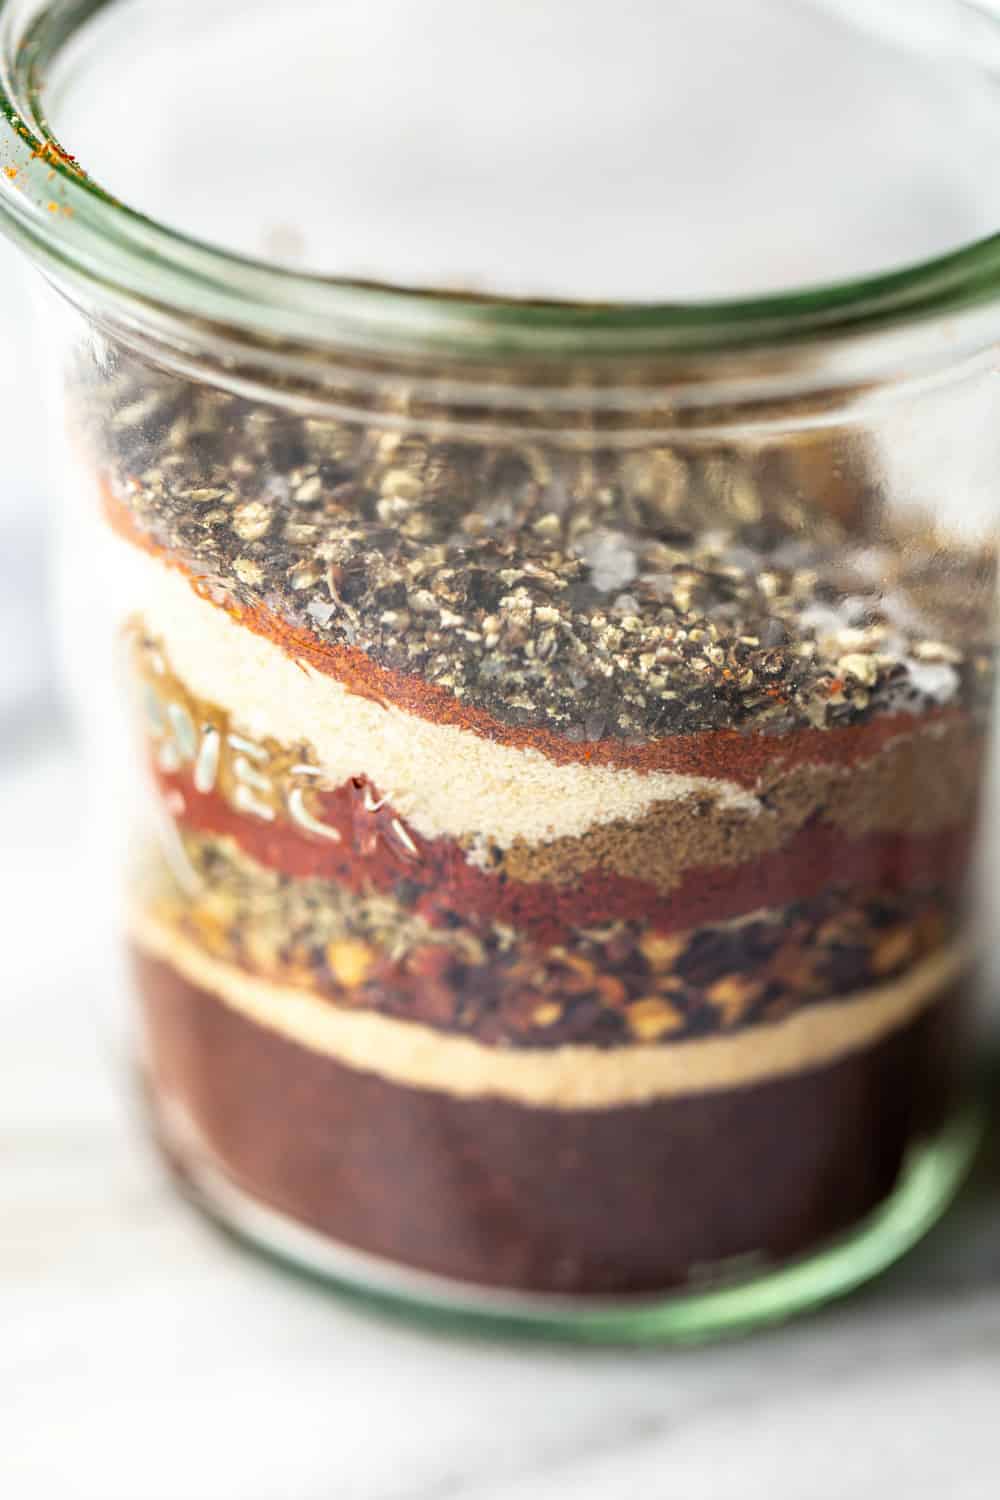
105 537 760 848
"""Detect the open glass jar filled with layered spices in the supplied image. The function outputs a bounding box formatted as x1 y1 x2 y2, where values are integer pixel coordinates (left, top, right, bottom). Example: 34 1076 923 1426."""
0 3 1000 1340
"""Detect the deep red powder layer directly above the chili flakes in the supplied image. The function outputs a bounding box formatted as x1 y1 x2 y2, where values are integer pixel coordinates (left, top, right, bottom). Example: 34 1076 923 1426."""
156 771 975 947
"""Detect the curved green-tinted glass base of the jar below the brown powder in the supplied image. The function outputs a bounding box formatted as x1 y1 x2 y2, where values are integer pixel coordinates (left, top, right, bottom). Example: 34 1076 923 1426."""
156 1106 984 1344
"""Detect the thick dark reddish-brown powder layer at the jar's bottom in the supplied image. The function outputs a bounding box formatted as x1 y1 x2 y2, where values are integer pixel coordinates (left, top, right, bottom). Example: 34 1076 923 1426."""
135 954 964 1295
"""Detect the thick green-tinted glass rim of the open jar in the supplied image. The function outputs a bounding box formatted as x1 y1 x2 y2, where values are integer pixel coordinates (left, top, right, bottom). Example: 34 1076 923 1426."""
0 0 1000 360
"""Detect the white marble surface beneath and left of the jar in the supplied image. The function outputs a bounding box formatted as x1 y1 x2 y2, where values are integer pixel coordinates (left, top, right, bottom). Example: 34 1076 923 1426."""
0 738 1000 1500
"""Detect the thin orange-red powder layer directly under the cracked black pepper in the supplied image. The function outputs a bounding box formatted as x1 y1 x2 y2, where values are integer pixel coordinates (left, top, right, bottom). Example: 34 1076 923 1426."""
103 486 964 789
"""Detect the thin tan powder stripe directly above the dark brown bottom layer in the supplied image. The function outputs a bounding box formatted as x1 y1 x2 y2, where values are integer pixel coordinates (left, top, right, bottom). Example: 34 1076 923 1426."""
132 914 969 1110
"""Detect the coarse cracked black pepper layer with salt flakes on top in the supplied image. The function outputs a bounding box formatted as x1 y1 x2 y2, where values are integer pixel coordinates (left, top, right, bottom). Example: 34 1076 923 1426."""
78 359 996 746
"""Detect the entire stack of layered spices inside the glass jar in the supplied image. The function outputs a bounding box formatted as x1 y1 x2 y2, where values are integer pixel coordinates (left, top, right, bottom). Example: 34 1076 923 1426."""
73 351 996 1293
